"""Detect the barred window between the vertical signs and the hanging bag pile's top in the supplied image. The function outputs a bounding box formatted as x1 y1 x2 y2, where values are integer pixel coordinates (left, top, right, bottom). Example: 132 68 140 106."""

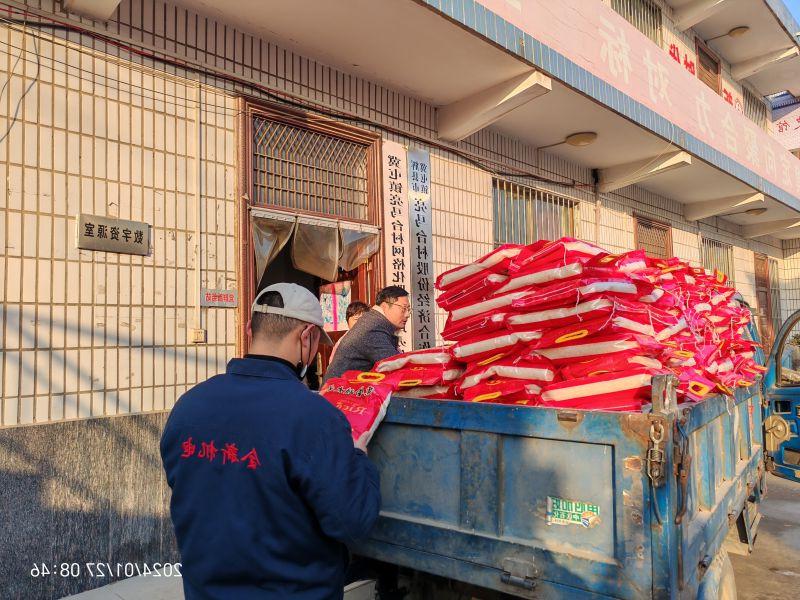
492 179 577 246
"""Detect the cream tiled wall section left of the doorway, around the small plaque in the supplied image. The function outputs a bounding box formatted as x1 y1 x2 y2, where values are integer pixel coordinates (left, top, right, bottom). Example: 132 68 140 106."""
0 16 236 425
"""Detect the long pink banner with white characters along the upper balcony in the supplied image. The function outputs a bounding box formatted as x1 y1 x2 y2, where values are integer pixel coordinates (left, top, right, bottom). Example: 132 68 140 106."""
482 0 800 197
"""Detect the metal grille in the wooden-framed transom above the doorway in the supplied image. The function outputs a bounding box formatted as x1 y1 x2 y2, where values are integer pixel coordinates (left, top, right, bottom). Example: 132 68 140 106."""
252 116 369 221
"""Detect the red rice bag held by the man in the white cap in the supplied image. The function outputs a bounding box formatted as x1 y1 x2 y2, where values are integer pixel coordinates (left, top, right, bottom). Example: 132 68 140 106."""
320 371 392 446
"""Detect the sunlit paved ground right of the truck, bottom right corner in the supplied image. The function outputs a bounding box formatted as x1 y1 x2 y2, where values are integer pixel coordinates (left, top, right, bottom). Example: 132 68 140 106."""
731 475 800 600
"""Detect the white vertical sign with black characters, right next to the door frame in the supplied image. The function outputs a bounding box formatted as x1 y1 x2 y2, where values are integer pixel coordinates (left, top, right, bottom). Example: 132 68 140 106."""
383 140 413 352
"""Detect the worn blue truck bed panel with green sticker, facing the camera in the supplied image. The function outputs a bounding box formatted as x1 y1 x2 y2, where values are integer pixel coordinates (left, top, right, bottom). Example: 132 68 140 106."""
358 398 655 598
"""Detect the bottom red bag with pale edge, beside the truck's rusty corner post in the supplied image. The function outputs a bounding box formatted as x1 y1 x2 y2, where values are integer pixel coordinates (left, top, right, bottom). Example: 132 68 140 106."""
542 369 654 410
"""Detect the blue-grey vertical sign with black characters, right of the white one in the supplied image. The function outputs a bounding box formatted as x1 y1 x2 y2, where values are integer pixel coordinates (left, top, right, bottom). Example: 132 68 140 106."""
408 148 436 350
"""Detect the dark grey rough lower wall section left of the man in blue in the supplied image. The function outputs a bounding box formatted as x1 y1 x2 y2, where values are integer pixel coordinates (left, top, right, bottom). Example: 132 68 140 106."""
0 412 180 599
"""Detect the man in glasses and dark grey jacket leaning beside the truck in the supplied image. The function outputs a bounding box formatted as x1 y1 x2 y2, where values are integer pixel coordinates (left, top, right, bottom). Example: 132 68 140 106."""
325 285 411 381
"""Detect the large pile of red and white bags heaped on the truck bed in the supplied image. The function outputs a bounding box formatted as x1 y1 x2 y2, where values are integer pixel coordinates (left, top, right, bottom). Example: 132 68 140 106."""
428 238 763 411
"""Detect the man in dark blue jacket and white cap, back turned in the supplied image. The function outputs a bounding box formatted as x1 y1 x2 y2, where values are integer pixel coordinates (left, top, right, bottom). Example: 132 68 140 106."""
161 283 380 600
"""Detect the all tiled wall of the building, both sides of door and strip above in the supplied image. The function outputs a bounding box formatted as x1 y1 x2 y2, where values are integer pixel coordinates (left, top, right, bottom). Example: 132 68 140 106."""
0 0 792 426
